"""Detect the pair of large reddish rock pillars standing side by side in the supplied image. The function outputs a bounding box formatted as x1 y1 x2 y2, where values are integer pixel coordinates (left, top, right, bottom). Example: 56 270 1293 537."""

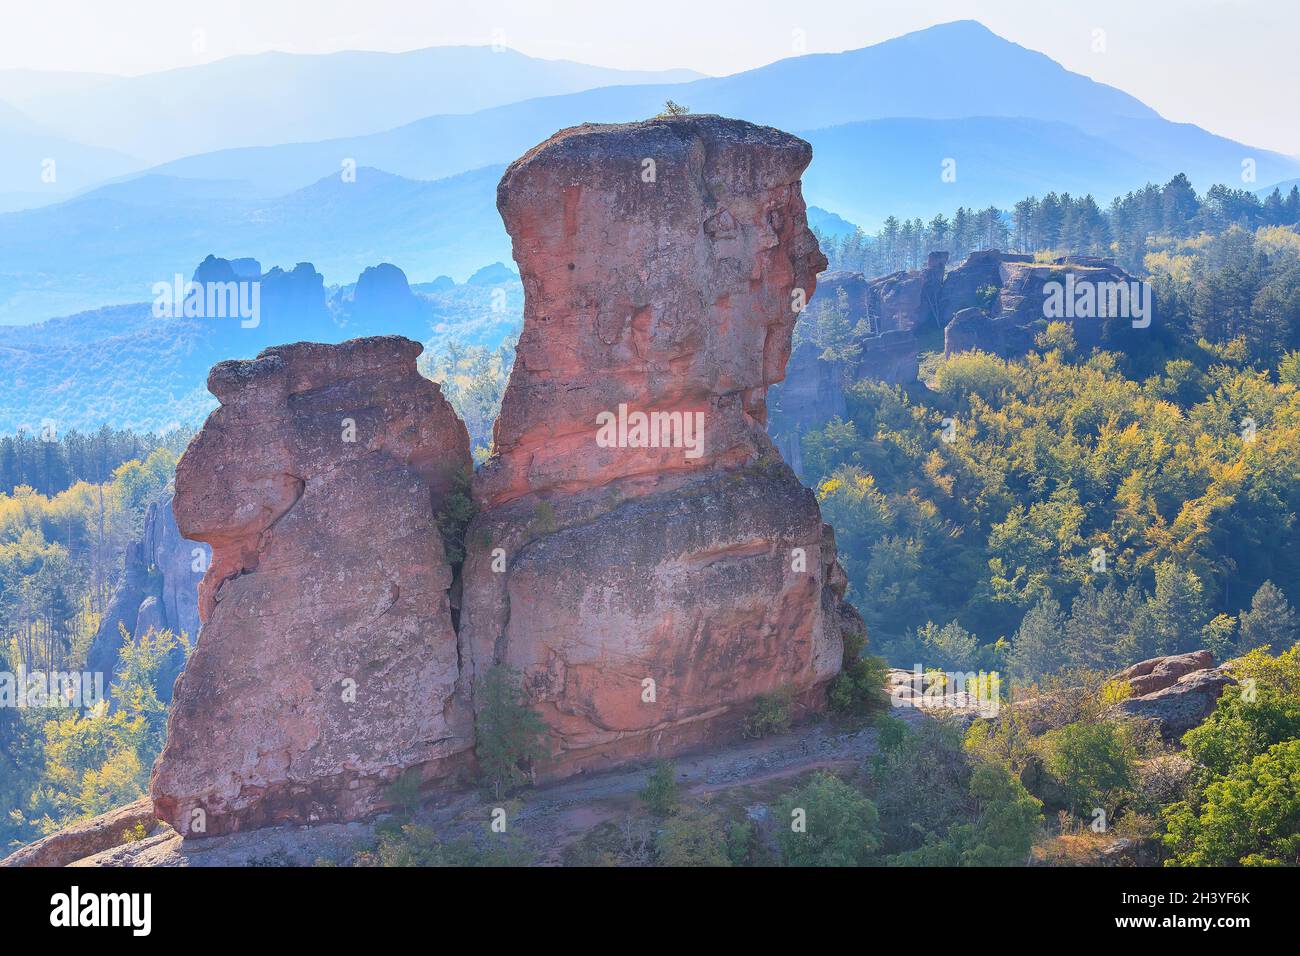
144 116 861 836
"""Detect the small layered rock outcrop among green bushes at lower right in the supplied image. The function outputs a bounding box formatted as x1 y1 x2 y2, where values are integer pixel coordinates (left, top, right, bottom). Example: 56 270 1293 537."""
1114 650 1236 739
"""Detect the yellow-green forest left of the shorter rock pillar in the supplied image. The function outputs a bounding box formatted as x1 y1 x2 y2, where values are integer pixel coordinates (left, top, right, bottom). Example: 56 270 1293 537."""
0 442 183 845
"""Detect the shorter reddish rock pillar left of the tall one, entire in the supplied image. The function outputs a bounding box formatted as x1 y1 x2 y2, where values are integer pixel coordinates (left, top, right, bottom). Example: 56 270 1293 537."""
151 337 473 835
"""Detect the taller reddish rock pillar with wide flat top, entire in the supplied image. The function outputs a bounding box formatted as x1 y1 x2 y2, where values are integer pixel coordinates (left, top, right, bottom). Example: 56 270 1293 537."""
462 116 857 777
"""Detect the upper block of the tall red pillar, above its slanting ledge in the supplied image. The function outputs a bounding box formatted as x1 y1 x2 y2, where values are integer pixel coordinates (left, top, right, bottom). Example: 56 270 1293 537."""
477 116 826 506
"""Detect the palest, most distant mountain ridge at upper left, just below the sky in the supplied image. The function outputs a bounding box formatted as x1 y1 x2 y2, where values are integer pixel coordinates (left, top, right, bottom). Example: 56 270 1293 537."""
0 47 699 166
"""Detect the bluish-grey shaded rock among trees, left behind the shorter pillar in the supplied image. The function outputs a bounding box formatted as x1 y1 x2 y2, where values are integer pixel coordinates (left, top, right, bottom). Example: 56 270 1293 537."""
86 496 211 702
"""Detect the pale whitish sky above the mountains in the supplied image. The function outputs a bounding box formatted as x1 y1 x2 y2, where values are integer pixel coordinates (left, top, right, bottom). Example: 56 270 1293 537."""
0 0 1300 155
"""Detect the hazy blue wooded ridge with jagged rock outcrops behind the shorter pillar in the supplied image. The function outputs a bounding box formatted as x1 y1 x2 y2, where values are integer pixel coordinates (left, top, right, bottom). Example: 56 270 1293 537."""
0 255 523 433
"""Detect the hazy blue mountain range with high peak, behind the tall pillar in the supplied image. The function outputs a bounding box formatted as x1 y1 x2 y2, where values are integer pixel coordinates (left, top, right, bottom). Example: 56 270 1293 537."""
0 21 1300 323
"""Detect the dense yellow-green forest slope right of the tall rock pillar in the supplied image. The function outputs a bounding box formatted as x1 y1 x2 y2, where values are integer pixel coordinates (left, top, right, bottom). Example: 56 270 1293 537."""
803 225 1300 676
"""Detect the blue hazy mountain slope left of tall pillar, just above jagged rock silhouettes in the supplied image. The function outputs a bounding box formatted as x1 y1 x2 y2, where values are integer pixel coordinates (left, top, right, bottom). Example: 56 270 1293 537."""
0 166 510 324
